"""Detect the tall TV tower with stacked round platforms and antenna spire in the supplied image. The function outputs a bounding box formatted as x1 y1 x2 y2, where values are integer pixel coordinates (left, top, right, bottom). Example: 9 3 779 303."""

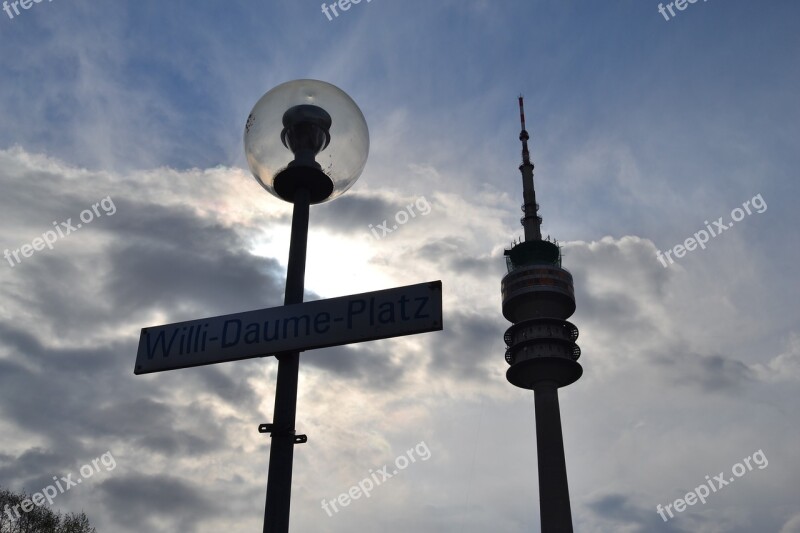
501 96 583 533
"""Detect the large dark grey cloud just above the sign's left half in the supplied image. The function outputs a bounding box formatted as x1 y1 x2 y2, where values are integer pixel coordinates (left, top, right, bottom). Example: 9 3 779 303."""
2 200 290 338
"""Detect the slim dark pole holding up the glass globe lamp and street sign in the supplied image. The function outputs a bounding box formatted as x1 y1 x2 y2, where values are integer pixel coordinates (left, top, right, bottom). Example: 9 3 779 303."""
264 188 310 533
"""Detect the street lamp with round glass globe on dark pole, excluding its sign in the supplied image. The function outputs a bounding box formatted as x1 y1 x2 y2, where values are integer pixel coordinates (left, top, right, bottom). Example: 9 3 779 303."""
244 80 369 533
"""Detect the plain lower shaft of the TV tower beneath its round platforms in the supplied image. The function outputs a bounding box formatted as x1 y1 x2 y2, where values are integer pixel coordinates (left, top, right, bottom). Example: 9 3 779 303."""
534 381 572 533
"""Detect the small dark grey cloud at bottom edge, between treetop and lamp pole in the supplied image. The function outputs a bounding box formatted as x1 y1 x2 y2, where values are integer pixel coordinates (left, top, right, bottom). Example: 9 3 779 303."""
100 475 220 533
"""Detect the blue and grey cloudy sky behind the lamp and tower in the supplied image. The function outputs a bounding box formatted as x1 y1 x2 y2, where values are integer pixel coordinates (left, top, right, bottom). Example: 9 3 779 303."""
0 0 800 533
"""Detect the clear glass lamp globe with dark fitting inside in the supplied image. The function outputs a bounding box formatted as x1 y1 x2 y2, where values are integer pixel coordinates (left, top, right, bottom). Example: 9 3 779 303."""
244 80 369 204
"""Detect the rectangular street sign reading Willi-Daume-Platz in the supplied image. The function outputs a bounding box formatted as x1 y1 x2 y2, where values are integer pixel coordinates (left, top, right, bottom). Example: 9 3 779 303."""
134 281 442 374
